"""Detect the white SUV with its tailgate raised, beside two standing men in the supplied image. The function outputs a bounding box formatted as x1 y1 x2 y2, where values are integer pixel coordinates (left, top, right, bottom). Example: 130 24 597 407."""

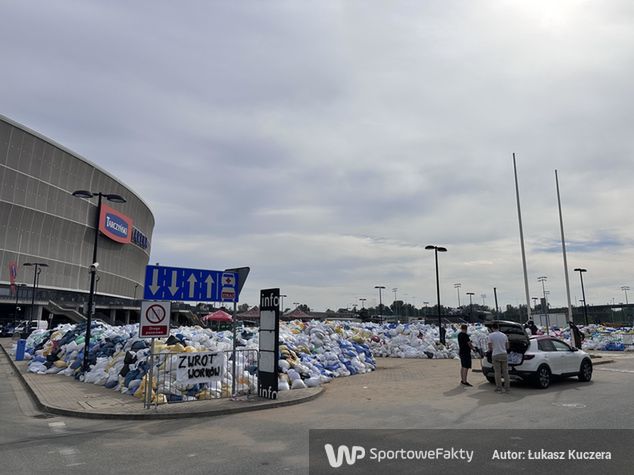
482 321 592 389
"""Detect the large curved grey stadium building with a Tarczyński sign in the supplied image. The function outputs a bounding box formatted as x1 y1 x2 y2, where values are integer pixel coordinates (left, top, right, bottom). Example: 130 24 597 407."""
0 115 154 323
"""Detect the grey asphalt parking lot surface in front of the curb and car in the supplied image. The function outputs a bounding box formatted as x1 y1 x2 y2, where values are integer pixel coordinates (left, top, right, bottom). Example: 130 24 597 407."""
0 355 634 474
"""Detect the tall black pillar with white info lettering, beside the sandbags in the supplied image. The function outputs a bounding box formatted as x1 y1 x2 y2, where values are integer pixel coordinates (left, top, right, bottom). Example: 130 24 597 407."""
258 289 280 399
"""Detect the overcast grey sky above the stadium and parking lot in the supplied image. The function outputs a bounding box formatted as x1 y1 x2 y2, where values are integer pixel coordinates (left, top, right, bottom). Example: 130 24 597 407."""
0 0 634 310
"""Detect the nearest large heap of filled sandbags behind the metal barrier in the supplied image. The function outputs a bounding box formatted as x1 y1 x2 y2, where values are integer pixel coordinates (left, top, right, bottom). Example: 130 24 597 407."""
25 322 376 403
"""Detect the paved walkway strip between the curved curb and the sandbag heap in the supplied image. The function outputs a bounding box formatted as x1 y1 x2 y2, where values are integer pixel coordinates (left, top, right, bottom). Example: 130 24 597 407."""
0 340 323 419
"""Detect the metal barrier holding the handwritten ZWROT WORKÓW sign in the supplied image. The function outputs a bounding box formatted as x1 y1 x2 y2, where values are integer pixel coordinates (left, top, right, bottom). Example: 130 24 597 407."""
146 349 258 407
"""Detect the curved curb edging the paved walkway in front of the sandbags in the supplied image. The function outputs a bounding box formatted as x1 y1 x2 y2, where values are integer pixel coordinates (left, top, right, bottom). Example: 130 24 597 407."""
0 345 326 420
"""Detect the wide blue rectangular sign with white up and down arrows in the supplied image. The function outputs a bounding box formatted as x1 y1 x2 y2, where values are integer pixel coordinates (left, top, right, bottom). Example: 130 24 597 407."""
143 266 241 302
